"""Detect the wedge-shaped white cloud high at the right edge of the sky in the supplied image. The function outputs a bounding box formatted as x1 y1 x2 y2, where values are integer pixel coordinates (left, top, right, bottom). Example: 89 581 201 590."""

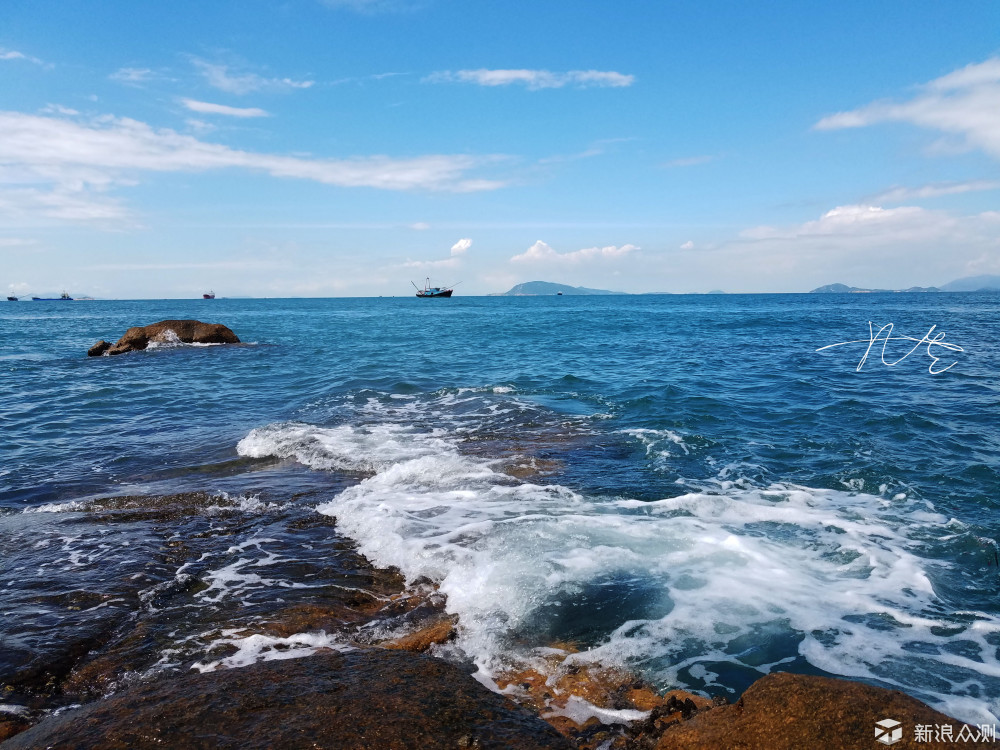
815 58 1000 158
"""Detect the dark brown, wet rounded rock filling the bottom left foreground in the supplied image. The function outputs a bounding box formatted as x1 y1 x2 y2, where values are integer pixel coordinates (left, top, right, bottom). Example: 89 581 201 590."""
3 649 573 750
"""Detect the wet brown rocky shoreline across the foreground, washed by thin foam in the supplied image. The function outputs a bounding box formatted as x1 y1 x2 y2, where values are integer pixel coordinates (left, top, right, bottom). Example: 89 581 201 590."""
0 493 992 750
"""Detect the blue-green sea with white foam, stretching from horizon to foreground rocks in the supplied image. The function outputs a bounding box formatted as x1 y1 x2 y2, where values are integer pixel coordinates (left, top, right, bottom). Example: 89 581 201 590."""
0 293 1000 724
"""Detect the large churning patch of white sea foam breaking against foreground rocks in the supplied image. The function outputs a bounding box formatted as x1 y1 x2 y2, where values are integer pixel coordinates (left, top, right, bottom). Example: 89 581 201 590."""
240 424 1000 722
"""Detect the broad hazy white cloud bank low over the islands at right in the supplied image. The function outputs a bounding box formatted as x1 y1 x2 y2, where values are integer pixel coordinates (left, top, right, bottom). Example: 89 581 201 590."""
642 205 1000 296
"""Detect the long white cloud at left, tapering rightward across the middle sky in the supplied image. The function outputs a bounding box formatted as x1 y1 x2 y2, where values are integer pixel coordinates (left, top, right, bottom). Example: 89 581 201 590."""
0 112 503 220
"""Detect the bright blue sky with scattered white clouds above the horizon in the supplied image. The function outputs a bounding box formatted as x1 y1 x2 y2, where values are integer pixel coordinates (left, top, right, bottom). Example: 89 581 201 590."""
0 0 1000 299
